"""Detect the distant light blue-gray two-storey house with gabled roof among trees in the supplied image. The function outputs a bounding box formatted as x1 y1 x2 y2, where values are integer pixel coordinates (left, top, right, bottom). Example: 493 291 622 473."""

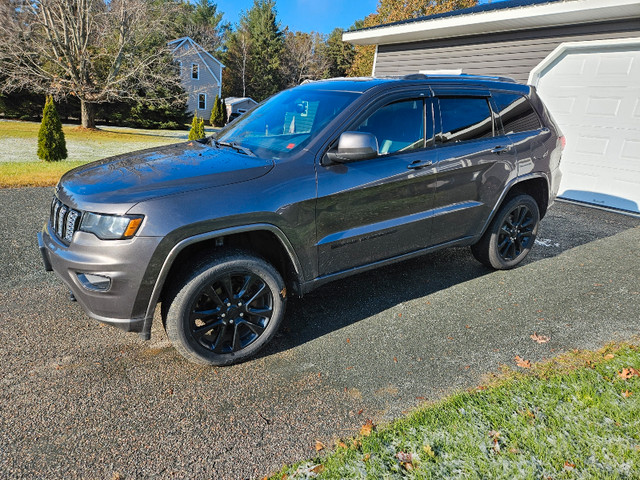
168 37 224 120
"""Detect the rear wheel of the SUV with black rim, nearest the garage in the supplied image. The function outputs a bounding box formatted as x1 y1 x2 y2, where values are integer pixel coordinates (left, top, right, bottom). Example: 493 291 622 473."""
471 195 540 270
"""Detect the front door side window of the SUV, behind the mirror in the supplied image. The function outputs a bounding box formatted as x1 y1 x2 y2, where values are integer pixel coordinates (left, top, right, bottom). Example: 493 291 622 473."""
354 99 424 155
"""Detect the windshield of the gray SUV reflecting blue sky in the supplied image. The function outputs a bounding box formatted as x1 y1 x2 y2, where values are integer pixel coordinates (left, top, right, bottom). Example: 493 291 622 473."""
215 88 358 158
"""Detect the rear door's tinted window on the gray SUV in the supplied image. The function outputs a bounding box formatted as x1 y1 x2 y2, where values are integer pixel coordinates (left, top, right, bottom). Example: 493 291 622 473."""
440 97 493 143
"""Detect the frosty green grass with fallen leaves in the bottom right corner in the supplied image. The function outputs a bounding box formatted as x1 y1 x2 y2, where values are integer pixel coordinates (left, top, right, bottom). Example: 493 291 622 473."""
271 345 640 480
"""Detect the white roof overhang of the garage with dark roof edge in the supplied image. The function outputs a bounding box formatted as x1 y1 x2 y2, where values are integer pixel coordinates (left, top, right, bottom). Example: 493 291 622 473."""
342 0 640 45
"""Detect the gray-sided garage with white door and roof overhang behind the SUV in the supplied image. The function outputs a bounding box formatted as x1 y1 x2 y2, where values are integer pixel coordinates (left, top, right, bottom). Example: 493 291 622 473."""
343 0 640 213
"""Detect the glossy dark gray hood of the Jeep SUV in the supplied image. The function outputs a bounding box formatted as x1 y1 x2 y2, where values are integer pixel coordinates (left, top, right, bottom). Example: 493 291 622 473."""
58 141 273 213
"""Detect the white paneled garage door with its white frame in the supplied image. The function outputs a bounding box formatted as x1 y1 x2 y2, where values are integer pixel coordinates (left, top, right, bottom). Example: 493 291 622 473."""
529 39 640 212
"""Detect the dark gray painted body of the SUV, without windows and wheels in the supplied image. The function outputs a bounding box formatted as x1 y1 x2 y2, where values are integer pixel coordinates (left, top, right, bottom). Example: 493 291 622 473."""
38 77 561 336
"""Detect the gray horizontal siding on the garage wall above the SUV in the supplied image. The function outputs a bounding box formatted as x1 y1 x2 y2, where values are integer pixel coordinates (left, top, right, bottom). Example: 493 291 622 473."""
375 19 640 83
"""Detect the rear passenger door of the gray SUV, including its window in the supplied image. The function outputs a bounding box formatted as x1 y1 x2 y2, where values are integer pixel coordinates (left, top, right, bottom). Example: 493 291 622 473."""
431 89 515 245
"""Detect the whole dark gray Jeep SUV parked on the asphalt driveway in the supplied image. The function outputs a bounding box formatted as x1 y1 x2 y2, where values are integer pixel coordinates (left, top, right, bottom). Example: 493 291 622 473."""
38 75 564 365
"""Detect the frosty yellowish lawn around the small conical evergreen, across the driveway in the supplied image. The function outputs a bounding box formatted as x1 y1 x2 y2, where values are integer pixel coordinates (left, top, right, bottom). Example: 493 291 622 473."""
0 120 205 187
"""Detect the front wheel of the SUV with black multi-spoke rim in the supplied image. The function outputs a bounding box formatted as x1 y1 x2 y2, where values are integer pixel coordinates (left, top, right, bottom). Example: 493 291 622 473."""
163 251 286 366
